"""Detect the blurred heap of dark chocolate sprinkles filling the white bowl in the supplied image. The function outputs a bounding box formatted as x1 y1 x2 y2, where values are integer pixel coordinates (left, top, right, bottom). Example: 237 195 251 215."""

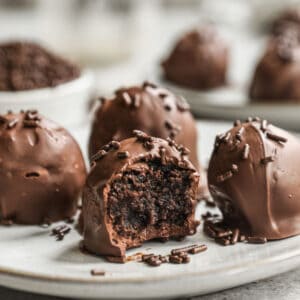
0 42 80 91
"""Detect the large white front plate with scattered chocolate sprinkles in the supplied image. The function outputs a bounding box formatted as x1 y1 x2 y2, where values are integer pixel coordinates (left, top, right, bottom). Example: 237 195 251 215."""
0 122 300 299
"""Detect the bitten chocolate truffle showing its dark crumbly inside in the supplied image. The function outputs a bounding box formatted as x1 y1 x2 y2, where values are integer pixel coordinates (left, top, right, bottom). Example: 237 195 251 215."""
82 131 199 257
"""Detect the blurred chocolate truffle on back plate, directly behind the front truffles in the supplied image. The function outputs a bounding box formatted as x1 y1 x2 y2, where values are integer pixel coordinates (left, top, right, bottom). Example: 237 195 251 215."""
162 27 228 90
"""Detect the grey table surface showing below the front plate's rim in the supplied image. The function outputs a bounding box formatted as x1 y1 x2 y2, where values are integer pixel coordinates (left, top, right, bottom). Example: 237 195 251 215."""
0 269 300 300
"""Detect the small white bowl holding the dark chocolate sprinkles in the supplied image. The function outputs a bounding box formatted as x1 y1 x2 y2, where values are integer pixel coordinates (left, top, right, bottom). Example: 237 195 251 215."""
0 71 94 127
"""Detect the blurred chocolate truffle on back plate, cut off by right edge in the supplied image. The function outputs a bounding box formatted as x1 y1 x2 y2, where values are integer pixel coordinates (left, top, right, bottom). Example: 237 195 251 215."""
250 29 300 103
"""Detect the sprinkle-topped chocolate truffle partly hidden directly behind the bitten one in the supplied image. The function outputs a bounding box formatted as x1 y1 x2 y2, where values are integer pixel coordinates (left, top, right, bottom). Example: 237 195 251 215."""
89 82 199 168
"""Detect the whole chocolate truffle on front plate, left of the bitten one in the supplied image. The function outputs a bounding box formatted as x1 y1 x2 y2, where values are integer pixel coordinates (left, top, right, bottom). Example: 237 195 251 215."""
0 110 86 224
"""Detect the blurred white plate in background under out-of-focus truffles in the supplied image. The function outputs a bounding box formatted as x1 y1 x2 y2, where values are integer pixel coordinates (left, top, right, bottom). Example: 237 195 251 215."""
153 71 300 131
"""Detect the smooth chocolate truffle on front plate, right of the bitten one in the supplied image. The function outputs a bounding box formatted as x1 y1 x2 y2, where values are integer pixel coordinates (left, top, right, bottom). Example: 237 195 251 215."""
208 119 300 240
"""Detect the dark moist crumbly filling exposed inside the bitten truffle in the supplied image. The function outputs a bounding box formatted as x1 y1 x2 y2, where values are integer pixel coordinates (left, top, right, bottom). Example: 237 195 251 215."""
107 160 193 239
